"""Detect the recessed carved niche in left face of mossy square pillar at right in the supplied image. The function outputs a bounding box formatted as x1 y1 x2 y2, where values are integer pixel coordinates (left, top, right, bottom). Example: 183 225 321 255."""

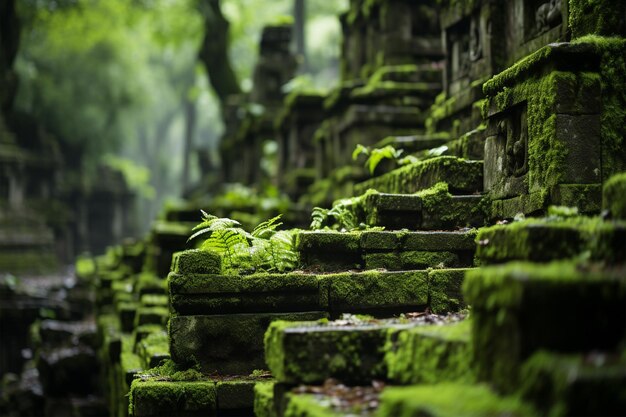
484 102 528 198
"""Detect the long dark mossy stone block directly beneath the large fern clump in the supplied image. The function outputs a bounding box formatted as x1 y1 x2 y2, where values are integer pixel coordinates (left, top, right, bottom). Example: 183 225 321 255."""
169 273 325 314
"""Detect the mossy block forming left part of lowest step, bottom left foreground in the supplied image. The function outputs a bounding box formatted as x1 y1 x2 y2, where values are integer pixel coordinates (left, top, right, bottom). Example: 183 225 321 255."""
129 379 217 417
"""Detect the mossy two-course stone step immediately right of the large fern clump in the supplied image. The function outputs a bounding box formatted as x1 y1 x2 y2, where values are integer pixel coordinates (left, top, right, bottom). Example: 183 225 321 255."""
296 230 476 271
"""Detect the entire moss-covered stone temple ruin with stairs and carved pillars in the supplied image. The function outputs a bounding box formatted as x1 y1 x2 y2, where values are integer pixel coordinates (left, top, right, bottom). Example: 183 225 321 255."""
0 0 626 417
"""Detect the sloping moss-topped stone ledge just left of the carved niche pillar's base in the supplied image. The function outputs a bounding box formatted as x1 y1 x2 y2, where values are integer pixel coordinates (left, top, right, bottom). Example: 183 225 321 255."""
354 156 483 195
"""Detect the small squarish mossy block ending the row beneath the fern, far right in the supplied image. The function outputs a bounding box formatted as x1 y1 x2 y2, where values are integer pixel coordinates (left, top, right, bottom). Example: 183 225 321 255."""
428 268 470 314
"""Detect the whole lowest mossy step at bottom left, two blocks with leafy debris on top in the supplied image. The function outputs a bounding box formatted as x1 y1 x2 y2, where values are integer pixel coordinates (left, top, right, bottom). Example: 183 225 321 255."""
130 369 268 417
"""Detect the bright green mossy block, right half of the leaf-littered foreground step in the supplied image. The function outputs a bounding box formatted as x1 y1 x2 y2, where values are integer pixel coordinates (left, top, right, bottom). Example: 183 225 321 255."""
385 319 474 384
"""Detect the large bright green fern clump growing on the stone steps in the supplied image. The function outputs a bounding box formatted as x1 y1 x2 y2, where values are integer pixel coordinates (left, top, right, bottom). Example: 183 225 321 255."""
189 210 298 273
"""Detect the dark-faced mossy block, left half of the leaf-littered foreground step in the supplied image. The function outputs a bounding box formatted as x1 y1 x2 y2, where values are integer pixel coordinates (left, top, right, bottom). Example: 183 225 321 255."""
265 321 411 384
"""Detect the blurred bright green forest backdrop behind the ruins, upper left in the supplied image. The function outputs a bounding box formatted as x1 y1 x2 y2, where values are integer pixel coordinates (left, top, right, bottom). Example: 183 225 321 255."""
15 0 347 234
